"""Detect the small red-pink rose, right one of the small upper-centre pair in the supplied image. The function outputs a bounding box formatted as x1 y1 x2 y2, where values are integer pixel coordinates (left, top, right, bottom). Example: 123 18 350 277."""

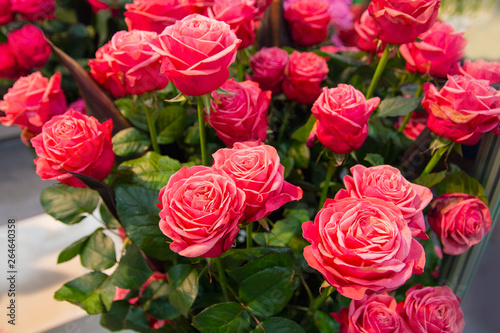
282 51 328 104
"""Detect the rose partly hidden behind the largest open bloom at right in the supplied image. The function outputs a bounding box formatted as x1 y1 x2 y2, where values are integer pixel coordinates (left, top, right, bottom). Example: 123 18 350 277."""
335 164 432 239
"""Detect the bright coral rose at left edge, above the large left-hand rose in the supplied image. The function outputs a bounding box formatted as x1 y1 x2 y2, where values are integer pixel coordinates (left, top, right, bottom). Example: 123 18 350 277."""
0 72 66 139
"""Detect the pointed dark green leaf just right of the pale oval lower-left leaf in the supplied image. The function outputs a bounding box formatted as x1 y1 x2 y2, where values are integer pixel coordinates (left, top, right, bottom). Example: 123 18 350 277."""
111 244 153 289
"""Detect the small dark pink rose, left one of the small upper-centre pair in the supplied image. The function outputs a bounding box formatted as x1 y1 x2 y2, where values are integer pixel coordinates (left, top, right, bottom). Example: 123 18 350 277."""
248 46 288 95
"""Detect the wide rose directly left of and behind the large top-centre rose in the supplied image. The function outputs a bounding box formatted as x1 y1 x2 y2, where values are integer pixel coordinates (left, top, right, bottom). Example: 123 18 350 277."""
89 30 168 97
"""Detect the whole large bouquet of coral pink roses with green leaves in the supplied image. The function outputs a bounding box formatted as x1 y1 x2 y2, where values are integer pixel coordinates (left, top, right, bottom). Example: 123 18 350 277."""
0 0 500 332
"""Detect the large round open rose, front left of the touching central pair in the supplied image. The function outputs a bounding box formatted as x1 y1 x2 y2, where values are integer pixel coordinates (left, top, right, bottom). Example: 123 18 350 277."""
158 166 245 258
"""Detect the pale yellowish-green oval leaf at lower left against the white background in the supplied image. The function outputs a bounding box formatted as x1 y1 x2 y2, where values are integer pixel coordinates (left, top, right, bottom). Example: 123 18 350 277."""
80 229 116 271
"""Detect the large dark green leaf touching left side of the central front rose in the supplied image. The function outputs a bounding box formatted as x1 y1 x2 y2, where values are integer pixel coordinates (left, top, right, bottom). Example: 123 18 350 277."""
116 186 172 260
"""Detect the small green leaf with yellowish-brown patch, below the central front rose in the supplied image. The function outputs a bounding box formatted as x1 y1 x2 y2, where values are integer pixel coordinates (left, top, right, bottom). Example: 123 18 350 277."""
167 265 199 317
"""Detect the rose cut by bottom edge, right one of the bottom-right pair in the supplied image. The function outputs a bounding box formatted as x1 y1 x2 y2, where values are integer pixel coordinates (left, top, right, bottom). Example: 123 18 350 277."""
399 285 465 333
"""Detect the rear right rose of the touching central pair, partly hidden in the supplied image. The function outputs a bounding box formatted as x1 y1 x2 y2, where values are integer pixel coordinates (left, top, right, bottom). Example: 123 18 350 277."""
213 141 302 222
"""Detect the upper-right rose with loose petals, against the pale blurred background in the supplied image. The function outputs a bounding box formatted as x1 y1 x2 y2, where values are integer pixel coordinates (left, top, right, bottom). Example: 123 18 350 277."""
399 22 467 78
